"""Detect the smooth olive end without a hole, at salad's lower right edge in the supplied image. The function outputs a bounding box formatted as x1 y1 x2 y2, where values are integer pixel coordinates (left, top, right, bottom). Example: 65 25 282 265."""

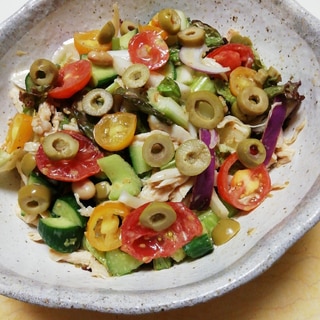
212 218 240 246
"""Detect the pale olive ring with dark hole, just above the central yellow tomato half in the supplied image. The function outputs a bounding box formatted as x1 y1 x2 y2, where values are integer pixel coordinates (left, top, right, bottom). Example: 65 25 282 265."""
82 88 113 116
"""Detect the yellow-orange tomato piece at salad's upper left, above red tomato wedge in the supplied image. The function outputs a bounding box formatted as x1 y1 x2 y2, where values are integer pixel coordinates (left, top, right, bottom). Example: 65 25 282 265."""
73 30 112 55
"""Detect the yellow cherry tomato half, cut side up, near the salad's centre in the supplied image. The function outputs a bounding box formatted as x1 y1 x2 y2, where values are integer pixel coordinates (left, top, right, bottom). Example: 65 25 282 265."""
93 112 137 151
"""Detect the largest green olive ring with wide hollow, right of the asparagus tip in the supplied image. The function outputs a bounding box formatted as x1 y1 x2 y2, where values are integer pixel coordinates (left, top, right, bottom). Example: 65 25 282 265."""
186 91 224 130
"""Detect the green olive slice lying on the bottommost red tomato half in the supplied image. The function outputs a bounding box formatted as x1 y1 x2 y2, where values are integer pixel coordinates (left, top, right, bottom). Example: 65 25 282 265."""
139 201 177 232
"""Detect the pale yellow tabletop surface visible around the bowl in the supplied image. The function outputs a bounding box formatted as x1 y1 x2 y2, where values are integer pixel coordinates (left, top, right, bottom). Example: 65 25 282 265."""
0 0 320 320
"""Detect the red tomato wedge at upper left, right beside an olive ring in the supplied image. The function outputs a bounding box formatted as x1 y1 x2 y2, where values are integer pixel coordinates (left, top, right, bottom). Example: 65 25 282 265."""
48 60 91 99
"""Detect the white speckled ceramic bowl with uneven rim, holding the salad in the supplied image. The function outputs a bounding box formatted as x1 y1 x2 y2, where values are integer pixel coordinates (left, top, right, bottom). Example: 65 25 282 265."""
0 0 320 314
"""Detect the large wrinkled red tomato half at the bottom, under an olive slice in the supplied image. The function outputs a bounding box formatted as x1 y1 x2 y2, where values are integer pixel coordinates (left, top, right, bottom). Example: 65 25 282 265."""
120 202 202 263
